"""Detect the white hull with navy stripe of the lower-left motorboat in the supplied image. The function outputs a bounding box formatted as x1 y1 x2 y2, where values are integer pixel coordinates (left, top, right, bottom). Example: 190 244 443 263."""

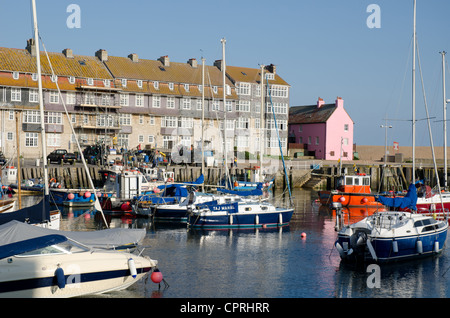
0 251 155 298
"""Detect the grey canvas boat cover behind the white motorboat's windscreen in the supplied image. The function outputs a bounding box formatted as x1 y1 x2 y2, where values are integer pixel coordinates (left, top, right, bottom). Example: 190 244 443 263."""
0 221 146 248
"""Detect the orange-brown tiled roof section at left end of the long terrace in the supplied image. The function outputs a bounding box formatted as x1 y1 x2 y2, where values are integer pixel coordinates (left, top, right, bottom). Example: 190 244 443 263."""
0 47 112 79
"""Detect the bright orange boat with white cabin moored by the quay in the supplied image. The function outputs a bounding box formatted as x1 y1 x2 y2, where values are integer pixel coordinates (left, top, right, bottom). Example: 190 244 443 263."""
318 173 383 208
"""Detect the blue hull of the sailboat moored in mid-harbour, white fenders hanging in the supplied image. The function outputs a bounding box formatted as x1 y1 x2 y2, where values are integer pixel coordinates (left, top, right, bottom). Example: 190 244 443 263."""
188 209 294 229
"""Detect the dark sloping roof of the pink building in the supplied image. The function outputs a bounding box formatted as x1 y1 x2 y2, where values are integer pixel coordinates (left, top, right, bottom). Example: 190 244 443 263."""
289 104 336 124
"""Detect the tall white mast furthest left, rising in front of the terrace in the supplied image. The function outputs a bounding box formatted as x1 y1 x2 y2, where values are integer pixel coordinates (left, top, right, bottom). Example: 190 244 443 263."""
31 0 50 196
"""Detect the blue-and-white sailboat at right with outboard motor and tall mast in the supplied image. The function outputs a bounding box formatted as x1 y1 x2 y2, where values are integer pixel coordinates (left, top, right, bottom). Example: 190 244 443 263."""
333 0 449 263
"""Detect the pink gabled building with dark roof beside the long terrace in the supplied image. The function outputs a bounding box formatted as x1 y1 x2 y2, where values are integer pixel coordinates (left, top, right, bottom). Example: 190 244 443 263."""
289 97 353 160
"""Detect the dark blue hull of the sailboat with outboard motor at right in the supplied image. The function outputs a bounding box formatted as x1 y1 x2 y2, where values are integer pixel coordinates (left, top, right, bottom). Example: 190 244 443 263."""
336 229 447 263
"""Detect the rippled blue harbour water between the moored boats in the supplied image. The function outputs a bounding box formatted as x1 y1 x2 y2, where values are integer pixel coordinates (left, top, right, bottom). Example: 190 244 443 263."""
25 189 450 299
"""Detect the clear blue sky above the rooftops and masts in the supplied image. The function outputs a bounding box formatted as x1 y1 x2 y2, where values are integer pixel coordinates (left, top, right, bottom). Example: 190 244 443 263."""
0 0 450 149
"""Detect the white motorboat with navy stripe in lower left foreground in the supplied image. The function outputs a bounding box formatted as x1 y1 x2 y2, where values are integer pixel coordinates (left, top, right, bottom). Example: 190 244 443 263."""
0 222 157 298
